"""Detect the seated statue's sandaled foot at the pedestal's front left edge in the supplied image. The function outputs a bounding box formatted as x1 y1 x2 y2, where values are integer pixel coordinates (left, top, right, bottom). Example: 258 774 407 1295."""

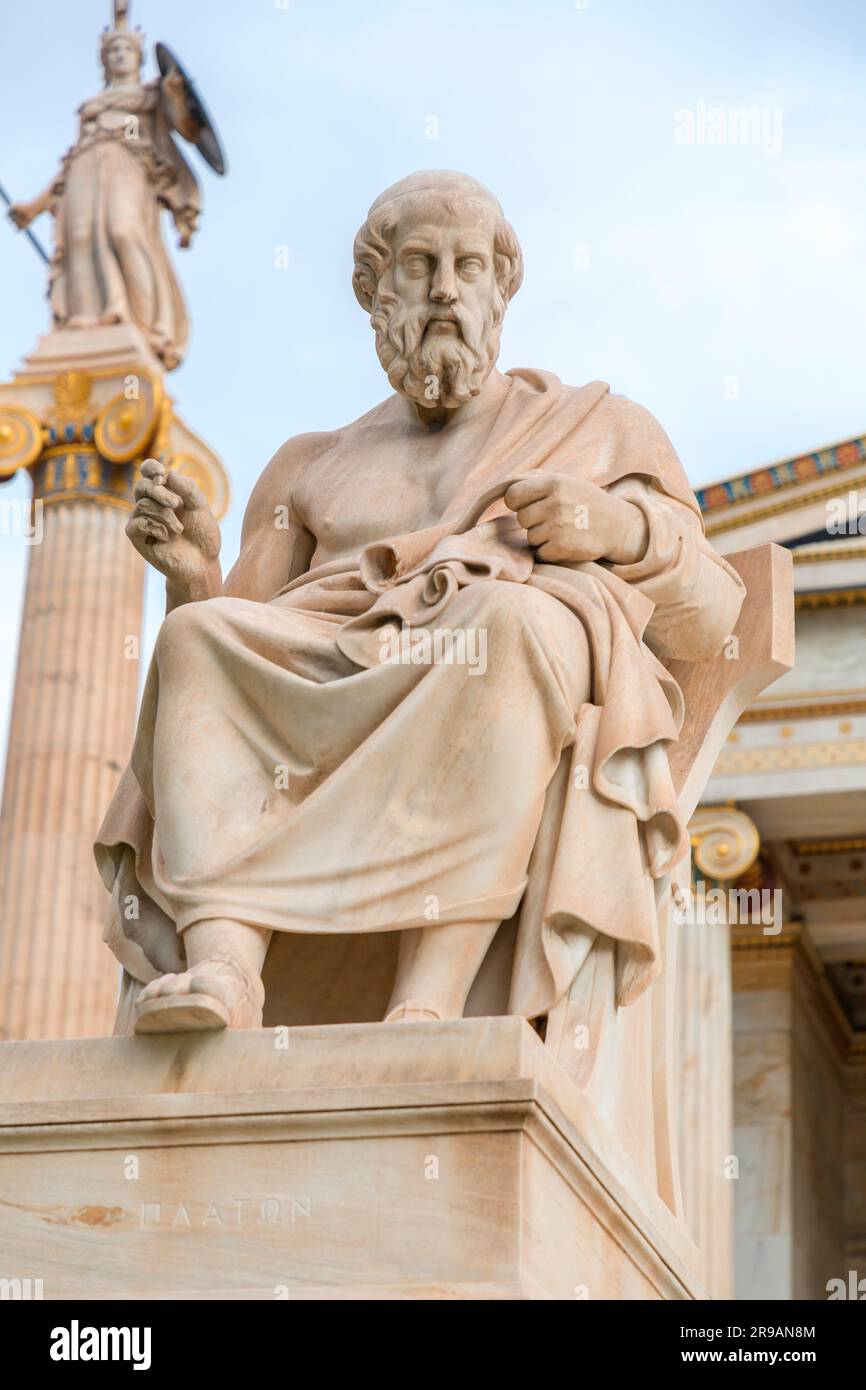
135 956 264 1033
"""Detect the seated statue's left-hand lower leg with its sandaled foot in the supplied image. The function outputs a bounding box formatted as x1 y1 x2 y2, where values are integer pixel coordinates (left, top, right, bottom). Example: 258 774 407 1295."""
135 922 271 1033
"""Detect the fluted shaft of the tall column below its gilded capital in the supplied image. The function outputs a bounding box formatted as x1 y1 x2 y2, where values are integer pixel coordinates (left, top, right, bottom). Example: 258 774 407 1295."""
0 499 145 1038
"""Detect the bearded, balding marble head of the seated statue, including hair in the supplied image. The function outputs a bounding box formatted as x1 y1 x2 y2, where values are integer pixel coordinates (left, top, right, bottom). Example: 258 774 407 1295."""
352 170 523 409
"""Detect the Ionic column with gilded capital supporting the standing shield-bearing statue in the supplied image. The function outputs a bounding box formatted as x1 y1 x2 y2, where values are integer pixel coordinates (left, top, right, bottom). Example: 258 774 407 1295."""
0 333 228 1040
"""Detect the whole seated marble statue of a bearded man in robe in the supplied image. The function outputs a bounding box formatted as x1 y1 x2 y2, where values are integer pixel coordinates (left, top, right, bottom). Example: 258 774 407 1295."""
96 171 745 1095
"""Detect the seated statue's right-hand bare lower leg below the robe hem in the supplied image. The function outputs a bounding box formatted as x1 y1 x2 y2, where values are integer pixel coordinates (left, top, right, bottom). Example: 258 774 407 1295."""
385 922 499 1023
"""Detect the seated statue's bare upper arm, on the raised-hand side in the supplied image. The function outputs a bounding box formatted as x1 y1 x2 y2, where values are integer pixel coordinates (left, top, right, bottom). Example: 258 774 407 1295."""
222 434 331 603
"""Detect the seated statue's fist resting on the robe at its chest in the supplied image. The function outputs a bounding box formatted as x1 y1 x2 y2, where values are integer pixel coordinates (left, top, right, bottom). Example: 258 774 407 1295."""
505 471 648 564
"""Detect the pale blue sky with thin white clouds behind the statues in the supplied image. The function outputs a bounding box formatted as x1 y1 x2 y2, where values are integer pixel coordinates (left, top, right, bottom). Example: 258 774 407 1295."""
0 0 866 767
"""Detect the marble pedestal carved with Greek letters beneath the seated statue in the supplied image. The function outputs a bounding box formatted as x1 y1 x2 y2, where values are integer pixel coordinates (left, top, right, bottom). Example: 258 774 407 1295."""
0 1017 706 1300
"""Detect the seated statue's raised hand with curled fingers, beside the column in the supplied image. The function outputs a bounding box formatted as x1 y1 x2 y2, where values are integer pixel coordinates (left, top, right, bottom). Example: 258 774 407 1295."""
126 459 220 598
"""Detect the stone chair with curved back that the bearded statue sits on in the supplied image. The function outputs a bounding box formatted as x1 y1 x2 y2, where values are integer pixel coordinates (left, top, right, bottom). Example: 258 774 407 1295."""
244 545 794 1239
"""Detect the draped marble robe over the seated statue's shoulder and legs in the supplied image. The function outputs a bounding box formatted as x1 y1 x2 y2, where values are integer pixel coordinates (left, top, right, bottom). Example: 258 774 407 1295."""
96 371 744 1034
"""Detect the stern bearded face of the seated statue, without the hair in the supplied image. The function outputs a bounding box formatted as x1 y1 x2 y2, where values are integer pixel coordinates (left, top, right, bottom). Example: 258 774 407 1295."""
371 209 506 410
